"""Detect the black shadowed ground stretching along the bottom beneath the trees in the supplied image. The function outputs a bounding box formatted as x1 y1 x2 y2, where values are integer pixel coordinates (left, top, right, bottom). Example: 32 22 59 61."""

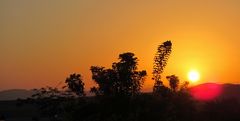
0 94 240 121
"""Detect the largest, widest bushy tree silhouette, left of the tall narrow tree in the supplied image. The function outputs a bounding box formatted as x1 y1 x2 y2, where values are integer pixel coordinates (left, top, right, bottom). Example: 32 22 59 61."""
90 52 146 96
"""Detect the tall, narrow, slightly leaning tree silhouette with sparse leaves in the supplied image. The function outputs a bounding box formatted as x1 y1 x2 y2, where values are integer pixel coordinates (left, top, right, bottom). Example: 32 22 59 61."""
152 41 172 93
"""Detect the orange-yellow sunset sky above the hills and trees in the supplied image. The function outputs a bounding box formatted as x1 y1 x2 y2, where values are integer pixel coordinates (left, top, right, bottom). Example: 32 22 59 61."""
0 0 240 91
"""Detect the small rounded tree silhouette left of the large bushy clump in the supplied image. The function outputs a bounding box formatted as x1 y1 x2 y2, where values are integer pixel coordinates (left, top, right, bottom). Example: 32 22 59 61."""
65 73 85 96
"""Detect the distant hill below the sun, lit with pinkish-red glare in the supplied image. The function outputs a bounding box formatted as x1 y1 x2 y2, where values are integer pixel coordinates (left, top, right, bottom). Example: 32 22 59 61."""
190 83 240 101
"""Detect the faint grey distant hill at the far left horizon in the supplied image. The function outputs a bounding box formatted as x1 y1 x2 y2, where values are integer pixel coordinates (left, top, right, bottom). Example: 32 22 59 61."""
0 89 33 101
